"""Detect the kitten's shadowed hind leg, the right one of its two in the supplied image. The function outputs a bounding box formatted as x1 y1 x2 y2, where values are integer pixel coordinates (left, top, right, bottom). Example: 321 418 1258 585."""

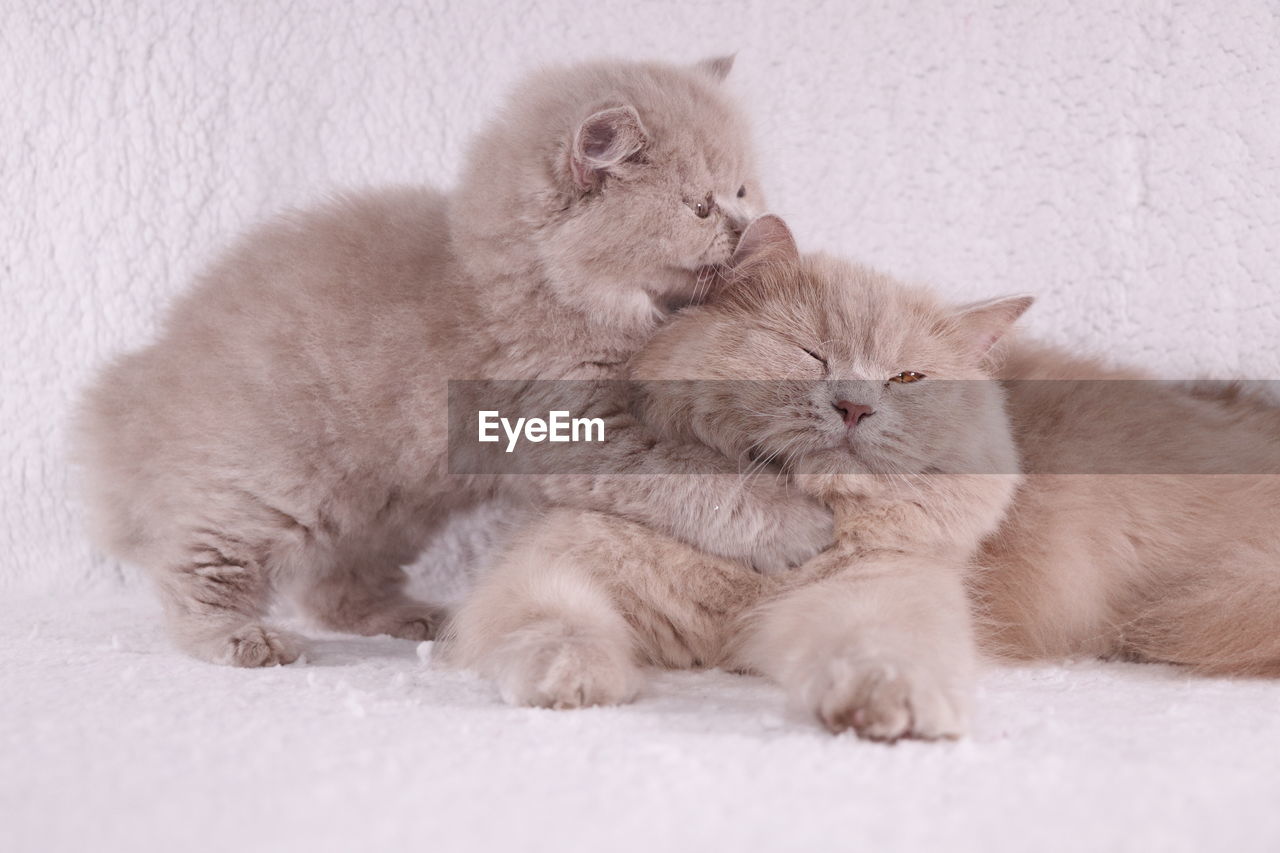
297 553 447 640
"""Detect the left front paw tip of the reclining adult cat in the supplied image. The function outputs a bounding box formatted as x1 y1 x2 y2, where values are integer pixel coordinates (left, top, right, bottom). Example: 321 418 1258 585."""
498 628 640 708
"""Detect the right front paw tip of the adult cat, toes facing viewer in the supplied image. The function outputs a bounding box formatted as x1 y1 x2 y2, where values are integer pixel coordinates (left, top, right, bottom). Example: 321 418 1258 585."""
803 656 968 743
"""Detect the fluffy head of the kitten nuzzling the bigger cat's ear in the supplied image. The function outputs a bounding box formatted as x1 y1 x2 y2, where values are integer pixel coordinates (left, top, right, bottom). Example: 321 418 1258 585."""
461 60 764 310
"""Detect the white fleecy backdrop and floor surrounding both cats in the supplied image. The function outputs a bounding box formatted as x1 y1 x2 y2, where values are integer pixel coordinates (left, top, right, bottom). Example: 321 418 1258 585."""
0 6 1280 850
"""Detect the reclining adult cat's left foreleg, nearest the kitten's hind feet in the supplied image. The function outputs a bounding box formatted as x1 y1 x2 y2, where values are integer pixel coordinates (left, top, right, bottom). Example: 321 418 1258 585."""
442 512 641 708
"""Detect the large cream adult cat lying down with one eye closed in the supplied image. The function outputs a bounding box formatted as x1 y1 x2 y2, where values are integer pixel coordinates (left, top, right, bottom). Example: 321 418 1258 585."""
445 216 1280 740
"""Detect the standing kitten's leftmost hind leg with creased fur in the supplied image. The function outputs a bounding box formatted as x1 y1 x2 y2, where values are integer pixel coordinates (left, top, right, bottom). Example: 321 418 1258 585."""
151 532 302 666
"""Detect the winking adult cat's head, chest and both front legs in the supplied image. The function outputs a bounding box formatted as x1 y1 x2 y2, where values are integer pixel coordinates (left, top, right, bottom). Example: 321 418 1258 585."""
445 216 1029 739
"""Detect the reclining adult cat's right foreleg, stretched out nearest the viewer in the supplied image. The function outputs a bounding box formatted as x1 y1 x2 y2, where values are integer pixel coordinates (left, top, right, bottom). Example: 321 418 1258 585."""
739 548 975 740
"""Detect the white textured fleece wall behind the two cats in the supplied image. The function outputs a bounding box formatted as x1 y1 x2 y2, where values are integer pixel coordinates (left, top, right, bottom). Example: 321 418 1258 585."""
0 0 1280 589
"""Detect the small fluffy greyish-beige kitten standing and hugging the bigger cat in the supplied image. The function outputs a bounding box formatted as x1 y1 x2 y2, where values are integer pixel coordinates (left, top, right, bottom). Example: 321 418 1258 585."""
74 58 831 666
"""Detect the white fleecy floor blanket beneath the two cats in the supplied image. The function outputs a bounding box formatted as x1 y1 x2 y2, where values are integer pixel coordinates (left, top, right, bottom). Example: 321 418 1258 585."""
0 598 1280 853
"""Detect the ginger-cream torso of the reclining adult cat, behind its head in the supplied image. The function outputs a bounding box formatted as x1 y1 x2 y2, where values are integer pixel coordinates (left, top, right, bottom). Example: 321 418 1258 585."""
972 342 1280 676
